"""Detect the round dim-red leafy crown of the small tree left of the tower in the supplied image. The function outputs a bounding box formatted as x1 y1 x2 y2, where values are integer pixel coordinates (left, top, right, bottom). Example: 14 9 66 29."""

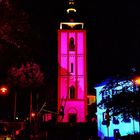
8 62 44 88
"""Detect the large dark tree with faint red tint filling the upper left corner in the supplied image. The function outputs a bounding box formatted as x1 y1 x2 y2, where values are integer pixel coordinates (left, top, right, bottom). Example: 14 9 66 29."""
0 0 40 81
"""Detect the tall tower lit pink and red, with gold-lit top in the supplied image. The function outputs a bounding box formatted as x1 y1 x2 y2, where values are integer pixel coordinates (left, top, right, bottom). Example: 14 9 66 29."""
58 0 87 123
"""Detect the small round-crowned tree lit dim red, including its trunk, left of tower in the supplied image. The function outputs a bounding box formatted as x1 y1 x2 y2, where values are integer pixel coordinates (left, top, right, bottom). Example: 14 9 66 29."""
8 62 45 119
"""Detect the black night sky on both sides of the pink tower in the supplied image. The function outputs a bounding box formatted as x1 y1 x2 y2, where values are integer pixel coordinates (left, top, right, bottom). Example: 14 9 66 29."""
22 0 140 87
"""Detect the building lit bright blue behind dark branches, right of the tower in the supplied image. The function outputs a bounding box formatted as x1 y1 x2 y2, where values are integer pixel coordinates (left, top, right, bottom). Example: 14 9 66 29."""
95 79 140 140
